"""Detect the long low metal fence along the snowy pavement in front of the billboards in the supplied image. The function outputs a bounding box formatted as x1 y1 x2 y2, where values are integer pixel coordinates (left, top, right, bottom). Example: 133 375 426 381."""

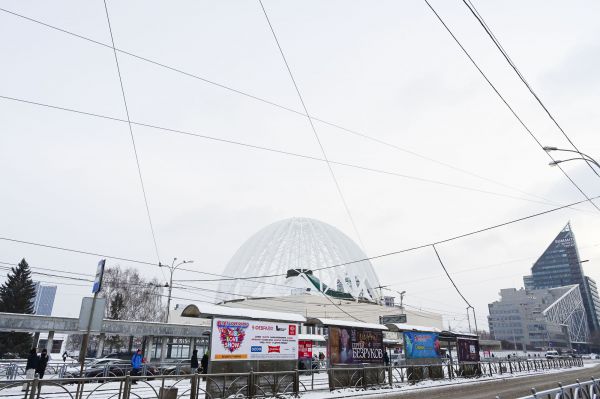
0 359 580 399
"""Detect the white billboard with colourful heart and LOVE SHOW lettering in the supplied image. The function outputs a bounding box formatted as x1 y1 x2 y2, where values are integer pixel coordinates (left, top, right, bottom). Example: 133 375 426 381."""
210 318 298 361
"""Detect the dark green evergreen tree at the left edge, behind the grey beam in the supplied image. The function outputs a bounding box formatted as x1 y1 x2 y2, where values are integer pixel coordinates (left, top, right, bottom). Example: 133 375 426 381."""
0 259 35 357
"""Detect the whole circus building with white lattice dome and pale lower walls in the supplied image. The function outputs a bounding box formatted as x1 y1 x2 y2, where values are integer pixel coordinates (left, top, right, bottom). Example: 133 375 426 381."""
218 217 442 332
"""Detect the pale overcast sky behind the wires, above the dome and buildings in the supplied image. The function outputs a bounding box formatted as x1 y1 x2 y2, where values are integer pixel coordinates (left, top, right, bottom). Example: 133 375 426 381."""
0 0 600 332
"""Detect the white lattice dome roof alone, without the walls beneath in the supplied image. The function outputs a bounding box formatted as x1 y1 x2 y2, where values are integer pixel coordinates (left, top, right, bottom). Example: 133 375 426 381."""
219 218 380 300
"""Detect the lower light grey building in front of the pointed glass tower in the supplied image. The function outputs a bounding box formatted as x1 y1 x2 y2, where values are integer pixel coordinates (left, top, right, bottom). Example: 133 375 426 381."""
488 285 589 349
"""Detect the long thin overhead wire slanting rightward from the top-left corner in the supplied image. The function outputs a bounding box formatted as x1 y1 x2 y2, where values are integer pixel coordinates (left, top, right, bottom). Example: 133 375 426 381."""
0 8 564 206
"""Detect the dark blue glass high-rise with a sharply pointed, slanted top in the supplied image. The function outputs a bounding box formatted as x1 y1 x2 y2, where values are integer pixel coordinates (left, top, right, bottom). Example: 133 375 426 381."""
523 223 600 330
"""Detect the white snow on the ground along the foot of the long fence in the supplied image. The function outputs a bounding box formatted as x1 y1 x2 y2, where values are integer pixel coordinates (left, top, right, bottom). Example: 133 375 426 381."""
0 361 600 399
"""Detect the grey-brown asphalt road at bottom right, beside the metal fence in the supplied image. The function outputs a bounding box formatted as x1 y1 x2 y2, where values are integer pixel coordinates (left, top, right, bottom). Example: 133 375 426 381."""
385 364 600 399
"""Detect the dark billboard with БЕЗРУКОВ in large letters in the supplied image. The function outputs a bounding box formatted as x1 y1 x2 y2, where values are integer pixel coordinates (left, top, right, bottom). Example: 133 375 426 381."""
327 326 384 364
